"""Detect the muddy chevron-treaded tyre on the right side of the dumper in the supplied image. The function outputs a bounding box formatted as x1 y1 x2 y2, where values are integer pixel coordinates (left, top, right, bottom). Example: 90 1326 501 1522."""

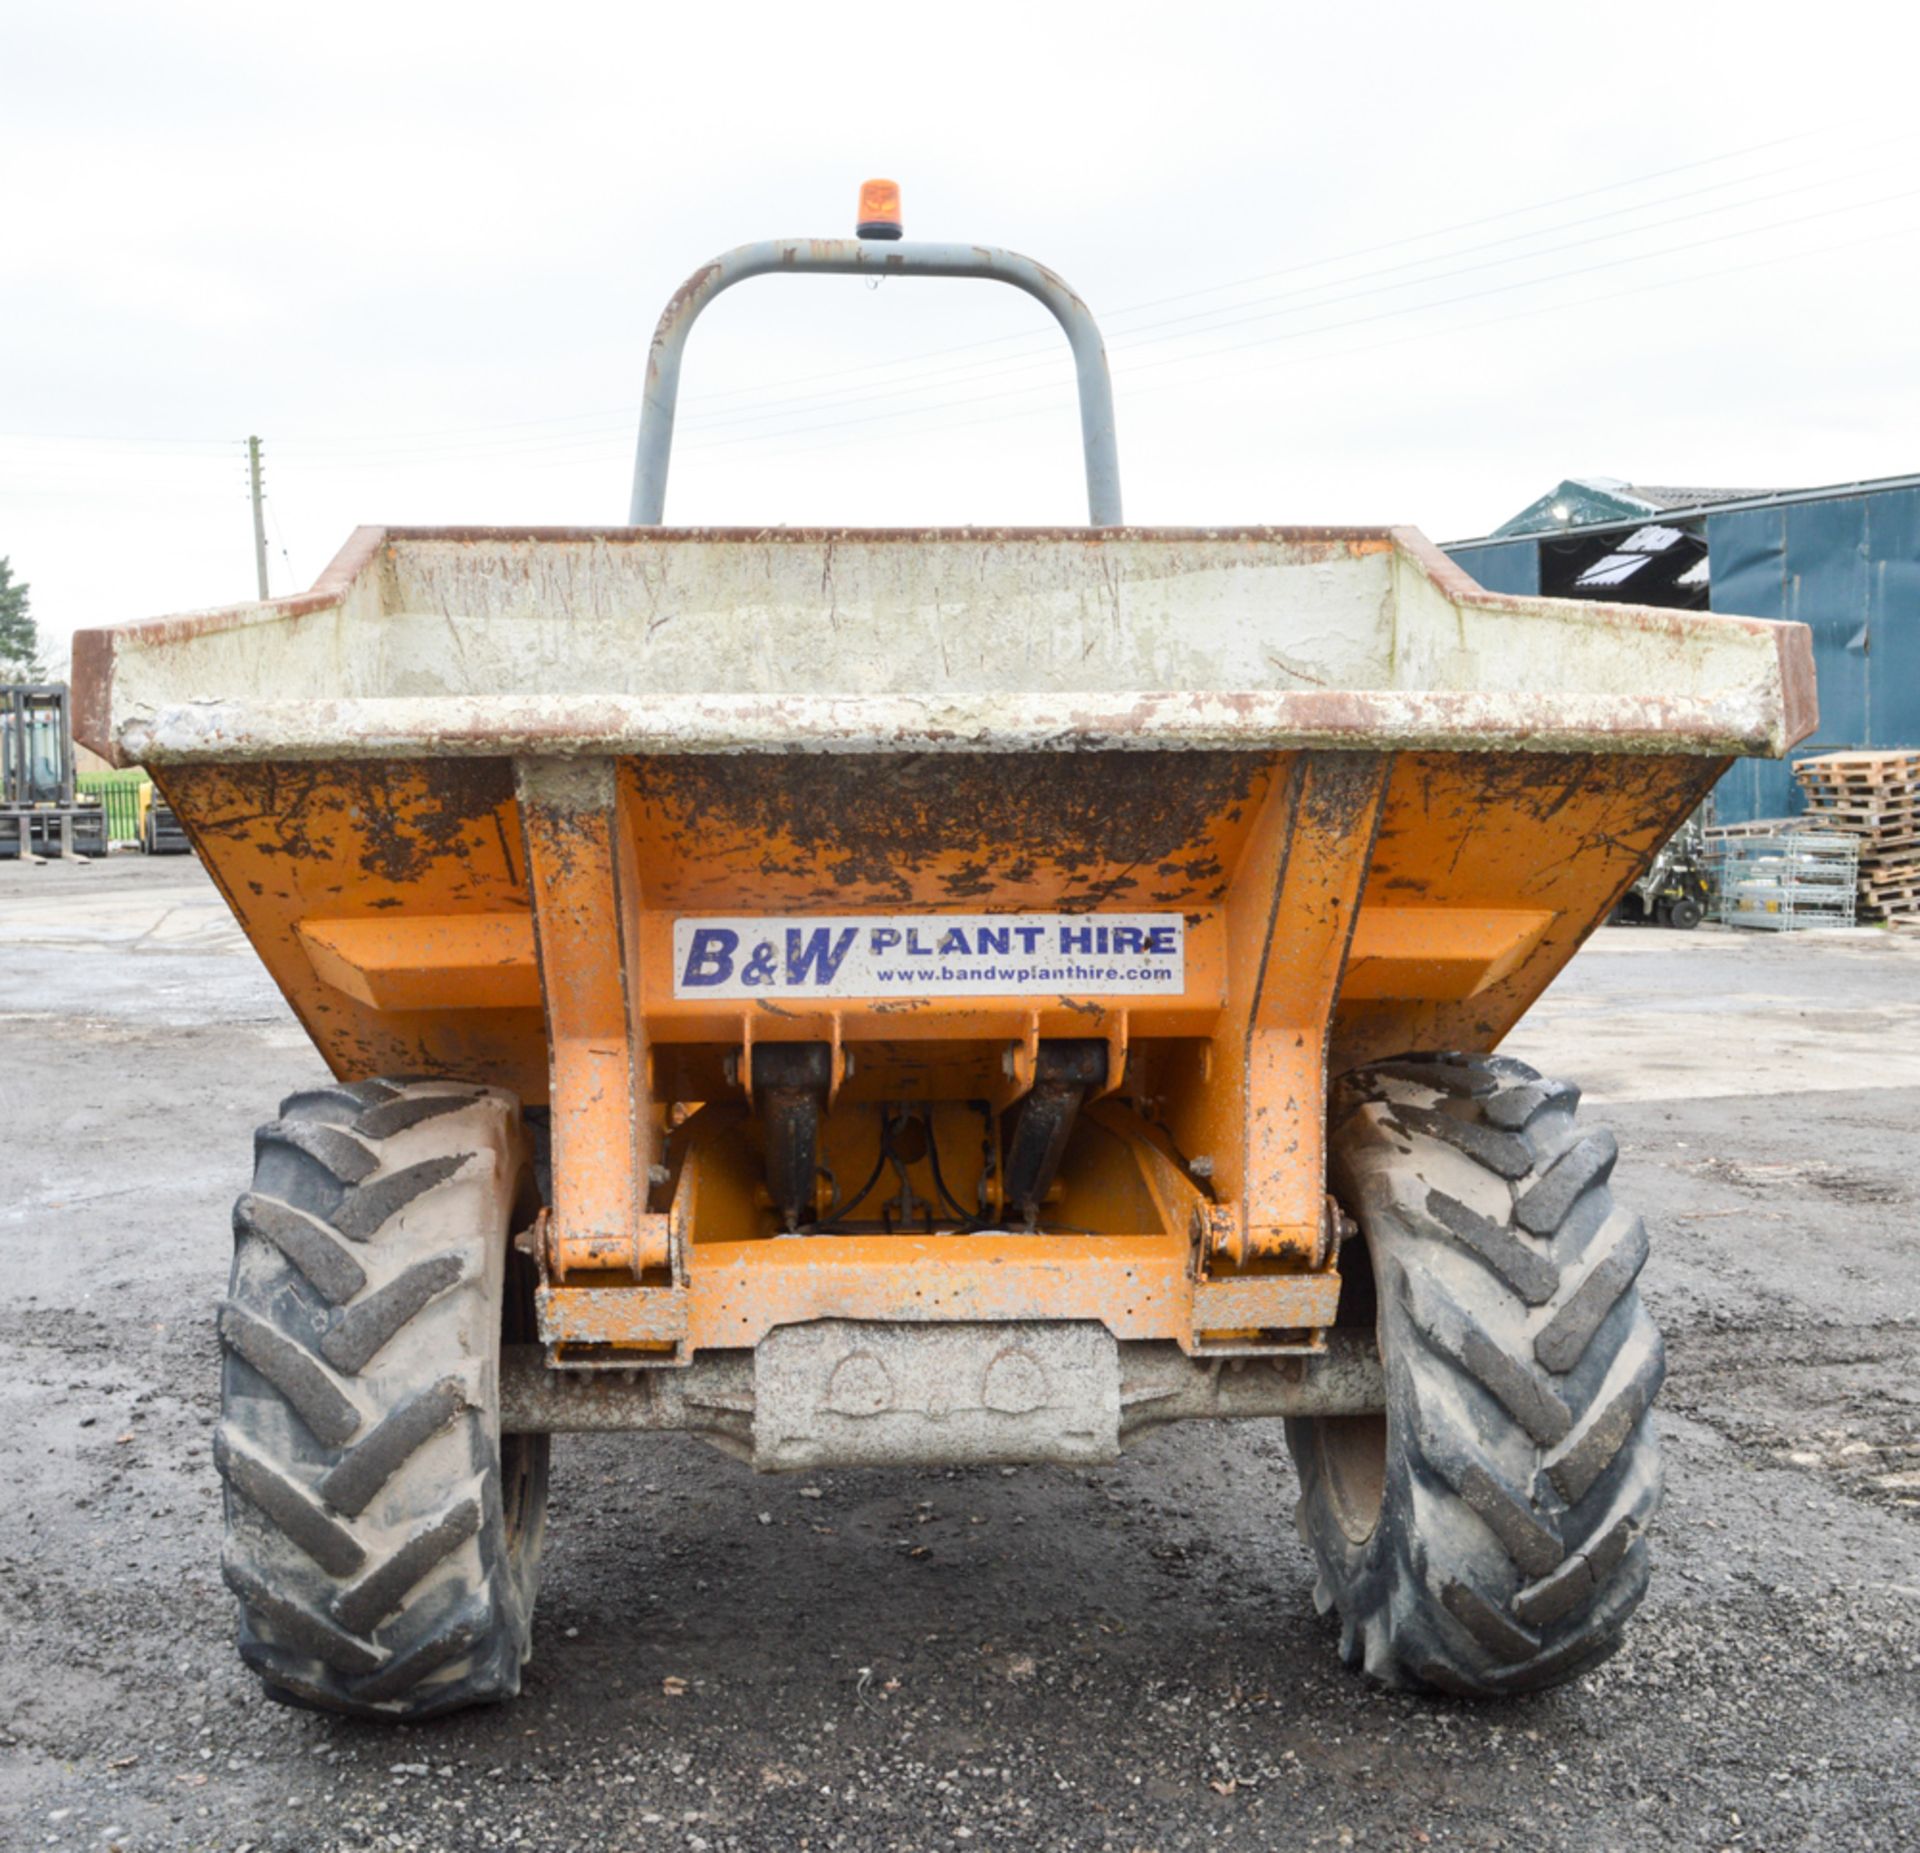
1286 1054 1665 1697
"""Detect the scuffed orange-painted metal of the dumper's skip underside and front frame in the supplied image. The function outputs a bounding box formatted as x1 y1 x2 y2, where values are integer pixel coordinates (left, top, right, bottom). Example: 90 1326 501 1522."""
161 751 1722 1361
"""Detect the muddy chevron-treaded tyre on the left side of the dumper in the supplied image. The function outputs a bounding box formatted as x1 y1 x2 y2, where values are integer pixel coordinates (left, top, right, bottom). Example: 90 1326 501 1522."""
213 1081 547 1721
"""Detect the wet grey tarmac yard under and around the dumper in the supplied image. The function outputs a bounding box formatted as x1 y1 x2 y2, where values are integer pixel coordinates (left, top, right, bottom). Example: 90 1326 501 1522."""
0 858 1920 1853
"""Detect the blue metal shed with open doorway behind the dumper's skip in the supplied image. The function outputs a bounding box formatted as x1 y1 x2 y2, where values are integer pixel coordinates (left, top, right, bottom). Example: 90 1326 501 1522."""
1446 476 1920 824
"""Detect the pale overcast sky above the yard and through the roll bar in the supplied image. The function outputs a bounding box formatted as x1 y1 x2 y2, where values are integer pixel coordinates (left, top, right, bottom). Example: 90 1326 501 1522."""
0 0 1920 661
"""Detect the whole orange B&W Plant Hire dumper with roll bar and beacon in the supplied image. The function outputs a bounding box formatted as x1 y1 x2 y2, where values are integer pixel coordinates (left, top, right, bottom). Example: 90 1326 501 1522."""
75 188 1814 1721
